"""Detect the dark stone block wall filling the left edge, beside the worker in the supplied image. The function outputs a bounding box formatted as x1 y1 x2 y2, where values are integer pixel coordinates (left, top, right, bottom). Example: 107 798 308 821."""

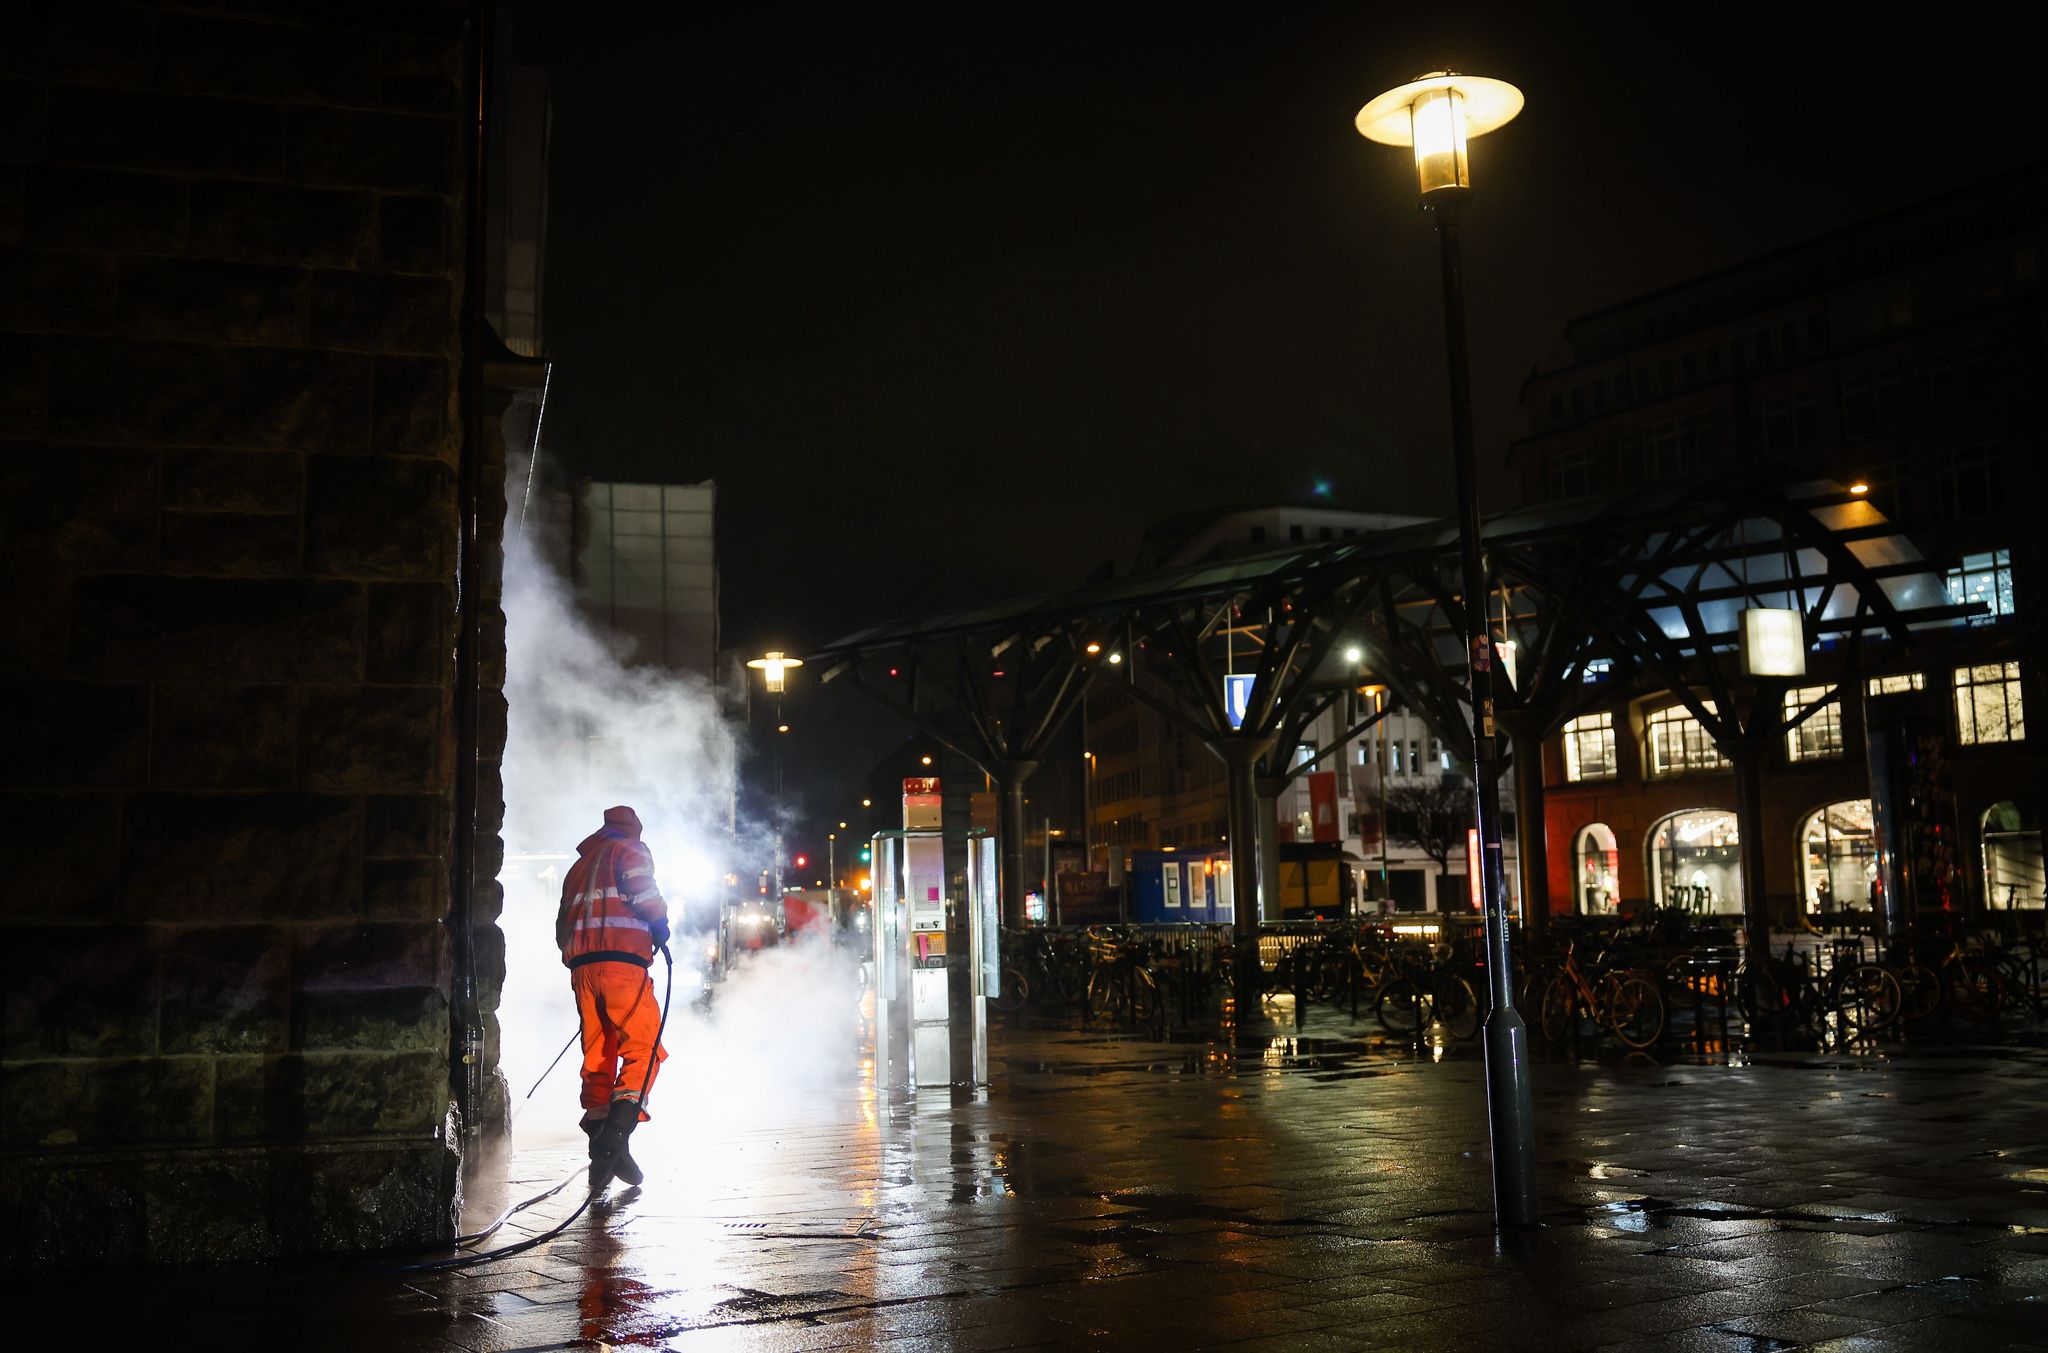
0 0 469 1261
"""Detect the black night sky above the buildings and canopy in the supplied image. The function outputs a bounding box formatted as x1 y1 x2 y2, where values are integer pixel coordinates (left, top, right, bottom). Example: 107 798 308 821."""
518 4 2044 843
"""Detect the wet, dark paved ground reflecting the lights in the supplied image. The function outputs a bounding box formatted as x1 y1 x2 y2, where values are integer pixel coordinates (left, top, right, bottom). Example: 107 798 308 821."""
10 1013 2048 1353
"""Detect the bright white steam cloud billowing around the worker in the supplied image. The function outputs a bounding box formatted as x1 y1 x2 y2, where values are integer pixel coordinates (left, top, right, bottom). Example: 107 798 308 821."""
498 467 860 1144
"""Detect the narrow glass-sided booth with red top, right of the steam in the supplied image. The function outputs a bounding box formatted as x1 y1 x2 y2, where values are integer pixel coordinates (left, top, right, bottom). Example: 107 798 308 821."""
870 769 997 1089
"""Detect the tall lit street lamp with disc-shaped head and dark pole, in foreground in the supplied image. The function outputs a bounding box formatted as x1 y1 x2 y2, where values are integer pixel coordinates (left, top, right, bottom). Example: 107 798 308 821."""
1358 72 1536 1226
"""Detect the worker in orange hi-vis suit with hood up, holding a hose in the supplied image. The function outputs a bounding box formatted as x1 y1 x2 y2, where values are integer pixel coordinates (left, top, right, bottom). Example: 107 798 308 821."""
555 804 668 1191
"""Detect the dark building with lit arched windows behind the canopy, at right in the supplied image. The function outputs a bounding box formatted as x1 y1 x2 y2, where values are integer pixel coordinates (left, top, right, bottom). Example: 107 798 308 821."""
1511 168 2048 917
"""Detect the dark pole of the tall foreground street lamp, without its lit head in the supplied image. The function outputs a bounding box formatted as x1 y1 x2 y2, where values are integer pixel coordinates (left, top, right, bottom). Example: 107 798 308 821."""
1427 197 1536 1226
